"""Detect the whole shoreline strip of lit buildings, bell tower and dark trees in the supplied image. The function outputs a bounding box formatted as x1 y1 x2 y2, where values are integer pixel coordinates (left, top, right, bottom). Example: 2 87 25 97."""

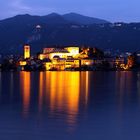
0 45 140 71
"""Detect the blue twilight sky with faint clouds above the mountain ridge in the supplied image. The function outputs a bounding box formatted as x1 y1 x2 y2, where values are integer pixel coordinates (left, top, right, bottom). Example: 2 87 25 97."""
0 0 140 22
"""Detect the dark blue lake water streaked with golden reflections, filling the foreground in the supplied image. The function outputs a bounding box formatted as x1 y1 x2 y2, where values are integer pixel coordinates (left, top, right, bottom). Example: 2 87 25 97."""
0 72 140 140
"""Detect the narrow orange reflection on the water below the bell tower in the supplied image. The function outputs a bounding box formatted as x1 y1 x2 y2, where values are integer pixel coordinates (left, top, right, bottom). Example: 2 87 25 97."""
20 72 31 117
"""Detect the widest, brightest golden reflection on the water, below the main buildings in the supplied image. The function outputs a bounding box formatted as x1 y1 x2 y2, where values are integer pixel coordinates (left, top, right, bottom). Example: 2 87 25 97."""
46 72 80 130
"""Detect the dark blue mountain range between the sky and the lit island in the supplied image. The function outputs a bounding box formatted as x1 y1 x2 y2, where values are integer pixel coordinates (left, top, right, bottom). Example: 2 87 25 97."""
0 13 140 53
